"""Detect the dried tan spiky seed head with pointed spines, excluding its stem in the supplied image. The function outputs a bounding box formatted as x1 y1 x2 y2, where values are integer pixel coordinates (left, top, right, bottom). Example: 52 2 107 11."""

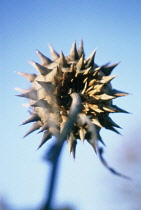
17 41 127 156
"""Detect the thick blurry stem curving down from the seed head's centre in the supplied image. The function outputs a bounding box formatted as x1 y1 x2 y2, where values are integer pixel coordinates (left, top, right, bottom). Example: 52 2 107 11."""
41 93 81 210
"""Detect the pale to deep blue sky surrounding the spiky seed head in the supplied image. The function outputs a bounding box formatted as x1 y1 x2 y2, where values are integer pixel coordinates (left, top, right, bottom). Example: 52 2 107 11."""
0 0 141 210
